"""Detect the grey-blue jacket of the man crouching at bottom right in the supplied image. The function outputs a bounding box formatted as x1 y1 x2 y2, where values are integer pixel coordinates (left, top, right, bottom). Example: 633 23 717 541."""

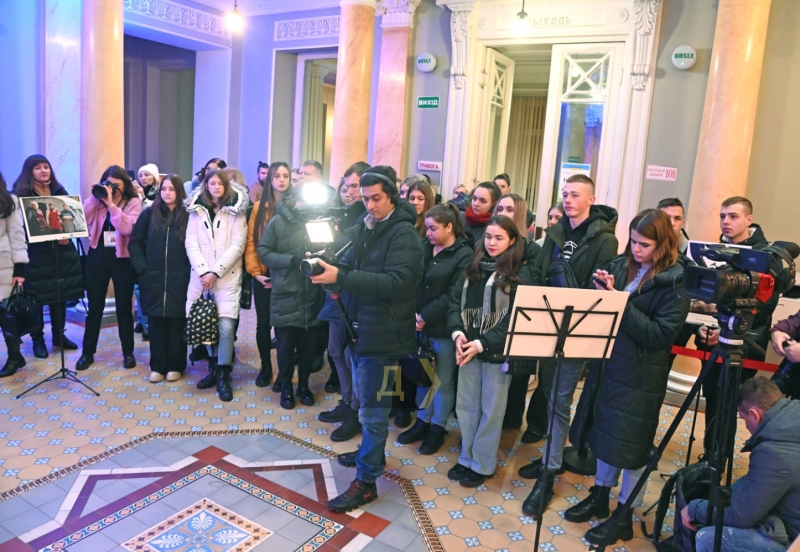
689 398 800 545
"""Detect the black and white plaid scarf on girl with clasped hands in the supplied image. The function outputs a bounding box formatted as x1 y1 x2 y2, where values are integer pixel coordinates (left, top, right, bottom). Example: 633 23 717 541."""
461 258 510 338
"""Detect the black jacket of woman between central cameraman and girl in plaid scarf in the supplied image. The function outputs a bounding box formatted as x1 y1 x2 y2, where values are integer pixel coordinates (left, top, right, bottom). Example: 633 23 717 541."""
417 237 473 338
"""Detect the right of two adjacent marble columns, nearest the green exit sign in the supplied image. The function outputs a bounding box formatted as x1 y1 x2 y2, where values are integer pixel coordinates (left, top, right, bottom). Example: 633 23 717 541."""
372 0 419 178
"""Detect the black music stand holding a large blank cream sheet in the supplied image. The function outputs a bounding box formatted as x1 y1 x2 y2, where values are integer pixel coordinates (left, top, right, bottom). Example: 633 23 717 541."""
505 286 629 550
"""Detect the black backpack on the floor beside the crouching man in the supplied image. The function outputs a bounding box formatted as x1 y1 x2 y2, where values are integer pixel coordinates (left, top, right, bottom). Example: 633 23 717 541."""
642 460 711 552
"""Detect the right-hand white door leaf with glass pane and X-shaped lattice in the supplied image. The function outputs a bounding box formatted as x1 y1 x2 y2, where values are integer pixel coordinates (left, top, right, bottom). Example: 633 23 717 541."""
536 43 624 222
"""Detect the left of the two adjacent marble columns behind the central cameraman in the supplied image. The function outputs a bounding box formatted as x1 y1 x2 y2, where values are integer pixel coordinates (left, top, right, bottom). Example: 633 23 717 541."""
330 0 375 183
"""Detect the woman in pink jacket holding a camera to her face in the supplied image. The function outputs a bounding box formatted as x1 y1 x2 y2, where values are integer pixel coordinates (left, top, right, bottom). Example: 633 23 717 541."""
75 165 142 370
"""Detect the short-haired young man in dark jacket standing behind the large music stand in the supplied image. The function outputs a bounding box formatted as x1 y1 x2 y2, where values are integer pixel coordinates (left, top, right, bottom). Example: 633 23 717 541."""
520 175 618 504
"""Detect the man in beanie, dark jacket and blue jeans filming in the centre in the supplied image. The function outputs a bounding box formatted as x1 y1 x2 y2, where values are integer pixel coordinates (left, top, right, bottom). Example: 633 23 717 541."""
311 166 422 512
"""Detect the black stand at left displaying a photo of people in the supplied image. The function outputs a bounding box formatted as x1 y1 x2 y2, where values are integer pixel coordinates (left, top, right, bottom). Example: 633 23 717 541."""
14 196 100 399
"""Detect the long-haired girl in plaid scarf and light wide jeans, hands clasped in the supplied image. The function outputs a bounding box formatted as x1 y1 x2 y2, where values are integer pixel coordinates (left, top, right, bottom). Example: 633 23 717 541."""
447 216 533 487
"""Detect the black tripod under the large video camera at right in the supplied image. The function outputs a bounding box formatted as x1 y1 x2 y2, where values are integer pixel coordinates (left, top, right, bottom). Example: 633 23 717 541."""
590 310 753 552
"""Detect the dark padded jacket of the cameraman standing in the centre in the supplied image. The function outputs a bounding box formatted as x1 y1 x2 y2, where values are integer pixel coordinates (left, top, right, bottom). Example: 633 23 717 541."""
338 202 422 358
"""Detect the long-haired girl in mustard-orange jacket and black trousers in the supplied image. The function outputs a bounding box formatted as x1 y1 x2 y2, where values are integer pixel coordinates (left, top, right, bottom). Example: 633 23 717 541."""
244 161 292 387
